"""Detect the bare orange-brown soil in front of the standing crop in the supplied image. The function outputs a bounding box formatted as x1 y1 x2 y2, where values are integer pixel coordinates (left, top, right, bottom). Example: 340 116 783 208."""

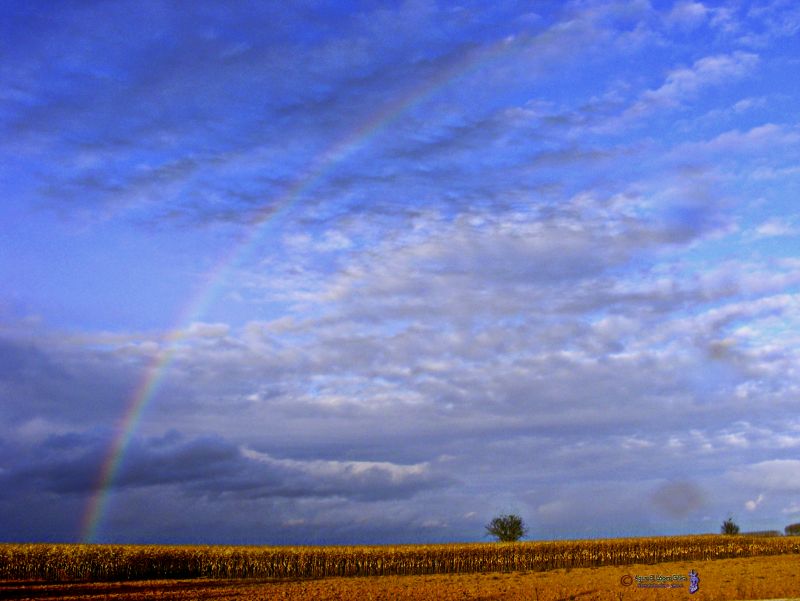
0 555 800 601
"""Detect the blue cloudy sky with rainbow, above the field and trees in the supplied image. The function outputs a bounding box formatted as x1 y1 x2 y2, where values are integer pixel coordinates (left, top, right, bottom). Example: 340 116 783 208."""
0 0 800 544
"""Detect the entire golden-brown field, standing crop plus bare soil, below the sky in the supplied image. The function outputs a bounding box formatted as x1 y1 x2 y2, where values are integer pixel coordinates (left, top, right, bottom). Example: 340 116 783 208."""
0 536 800 601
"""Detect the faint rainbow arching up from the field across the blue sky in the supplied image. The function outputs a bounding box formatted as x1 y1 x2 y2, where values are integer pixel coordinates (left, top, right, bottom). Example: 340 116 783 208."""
80 39 516 543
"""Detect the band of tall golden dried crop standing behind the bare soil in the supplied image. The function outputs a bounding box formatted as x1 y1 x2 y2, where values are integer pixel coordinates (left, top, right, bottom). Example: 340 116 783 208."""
0 535 800 581
